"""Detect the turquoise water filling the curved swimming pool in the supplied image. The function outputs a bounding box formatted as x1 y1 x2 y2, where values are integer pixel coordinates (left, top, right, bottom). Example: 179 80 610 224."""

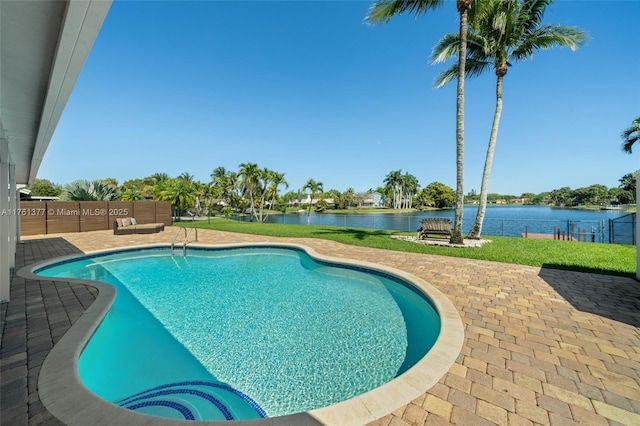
36 247 440 420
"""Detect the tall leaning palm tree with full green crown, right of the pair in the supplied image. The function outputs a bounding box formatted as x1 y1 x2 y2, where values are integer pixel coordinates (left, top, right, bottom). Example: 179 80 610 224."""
431 0 586 239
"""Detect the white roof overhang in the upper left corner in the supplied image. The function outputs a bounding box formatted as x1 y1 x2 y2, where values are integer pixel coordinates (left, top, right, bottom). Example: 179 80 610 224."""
0 0 111 185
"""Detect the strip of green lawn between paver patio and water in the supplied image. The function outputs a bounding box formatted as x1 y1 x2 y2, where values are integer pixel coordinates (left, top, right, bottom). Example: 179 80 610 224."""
174 218 636 277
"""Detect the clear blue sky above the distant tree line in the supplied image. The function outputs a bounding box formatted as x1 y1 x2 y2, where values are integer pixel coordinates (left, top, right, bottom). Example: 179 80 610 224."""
38 0 640 195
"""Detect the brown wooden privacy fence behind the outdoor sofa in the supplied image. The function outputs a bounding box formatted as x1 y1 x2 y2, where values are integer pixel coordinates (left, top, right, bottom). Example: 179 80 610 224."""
16 201 171 235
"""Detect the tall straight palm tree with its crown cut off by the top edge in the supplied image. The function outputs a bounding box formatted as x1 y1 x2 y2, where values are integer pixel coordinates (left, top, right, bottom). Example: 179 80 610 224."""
366 0 475 244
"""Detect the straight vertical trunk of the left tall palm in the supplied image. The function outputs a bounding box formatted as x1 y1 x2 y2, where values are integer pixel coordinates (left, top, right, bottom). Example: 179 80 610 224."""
449 0 471 244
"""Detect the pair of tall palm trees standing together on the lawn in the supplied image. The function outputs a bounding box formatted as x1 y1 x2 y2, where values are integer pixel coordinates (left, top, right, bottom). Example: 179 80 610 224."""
366 0 588 243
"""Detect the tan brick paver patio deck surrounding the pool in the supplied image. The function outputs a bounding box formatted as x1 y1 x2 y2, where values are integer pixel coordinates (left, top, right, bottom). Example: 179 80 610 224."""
0 227 640 426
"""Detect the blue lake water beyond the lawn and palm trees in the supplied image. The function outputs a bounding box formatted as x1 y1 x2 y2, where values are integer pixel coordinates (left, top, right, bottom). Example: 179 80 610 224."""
249 206 627 243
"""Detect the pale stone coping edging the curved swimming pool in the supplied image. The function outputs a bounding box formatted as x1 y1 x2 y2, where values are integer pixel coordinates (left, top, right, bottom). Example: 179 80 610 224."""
17 242 464 426
